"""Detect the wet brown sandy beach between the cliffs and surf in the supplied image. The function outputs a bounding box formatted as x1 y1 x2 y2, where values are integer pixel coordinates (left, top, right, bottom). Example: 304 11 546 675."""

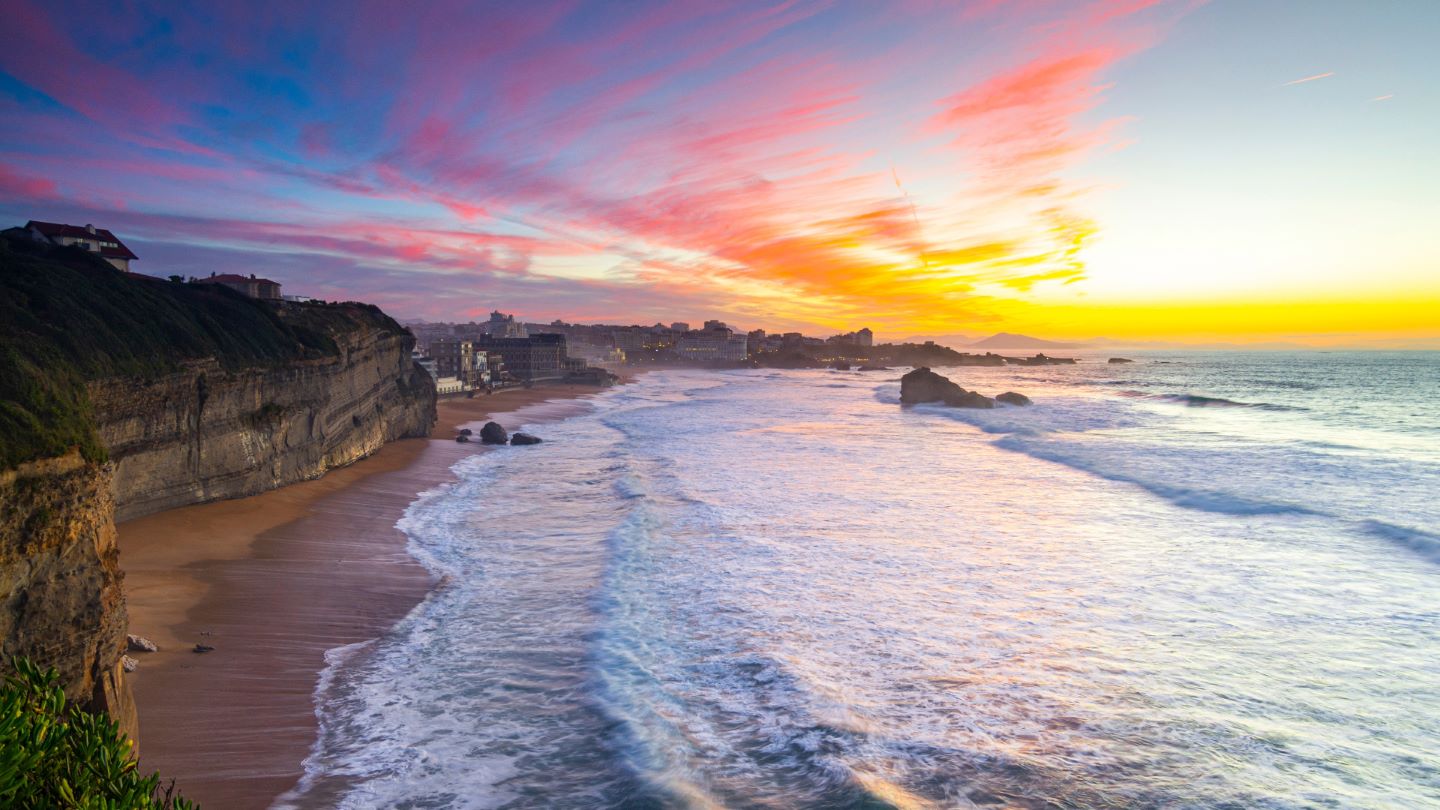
120 385 624 810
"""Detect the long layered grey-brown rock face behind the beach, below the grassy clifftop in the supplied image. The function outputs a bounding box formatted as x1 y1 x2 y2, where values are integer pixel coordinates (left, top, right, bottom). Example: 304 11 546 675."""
89 315 435 520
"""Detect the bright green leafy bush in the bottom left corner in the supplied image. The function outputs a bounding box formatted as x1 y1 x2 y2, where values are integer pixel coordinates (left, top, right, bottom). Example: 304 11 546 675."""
0 659 197 810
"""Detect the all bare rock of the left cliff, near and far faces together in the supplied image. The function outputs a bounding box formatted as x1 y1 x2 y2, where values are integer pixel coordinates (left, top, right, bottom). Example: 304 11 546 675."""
0 312 435 736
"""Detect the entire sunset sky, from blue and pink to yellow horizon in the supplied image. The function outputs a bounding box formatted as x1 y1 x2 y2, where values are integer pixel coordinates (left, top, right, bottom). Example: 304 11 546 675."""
0 0 1440 346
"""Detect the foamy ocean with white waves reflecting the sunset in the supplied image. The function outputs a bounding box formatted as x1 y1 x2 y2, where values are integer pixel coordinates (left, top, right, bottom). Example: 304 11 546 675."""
279 352 1440 809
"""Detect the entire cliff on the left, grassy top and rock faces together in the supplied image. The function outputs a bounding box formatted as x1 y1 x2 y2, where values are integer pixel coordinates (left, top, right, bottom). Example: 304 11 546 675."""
0 232 435 732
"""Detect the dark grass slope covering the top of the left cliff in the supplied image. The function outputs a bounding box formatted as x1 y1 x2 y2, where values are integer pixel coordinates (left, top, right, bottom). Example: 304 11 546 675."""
0 236 402 470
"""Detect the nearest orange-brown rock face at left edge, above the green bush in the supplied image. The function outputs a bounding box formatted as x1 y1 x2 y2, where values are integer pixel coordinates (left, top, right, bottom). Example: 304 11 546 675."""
0 453 135 735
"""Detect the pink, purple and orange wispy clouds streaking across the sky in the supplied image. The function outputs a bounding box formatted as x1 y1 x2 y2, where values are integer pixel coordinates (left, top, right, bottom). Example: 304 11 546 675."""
0 0 1186 330
